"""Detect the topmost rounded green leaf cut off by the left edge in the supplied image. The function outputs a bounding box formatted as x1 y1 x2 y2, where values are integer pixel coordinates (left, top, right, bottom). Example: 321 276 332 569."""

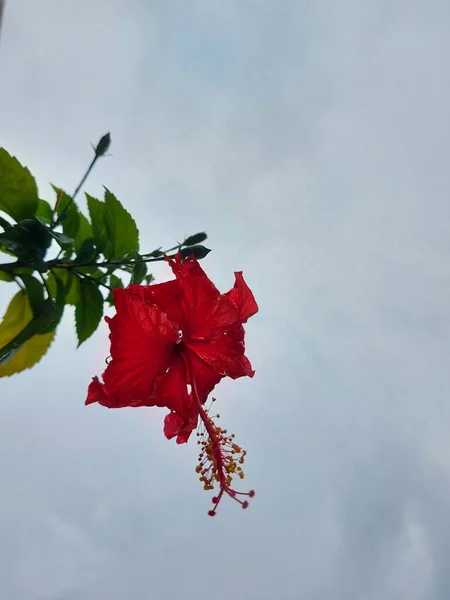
0 148 39 221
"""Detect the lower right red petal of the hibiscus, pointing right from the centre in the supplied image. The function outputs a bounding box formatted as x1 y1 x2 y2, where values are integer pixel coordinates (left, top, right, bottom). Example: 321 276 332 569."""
189 325 255 379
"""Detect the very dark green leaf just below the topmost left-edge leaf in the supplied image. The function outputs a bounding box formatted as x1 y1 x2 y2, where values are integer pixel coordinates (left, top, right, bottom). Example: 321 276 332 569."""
0 218 52 264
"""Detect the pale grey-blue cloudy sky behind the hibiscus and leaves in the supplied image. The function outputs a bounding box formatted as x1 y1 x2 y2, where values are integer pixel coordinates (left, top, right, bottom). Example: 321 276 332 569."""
0 0 450 600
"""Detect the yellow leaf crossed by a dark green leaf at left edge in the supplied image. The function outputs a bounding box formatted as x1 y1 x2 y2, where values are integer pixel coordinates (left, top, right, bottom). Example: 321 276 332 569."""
0 292 55 377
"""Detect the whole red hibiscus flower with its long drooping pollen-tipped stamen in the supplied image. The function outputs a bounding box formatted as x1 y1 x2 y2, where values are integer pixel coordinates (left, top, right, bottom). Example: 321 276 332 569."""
86 254 258 515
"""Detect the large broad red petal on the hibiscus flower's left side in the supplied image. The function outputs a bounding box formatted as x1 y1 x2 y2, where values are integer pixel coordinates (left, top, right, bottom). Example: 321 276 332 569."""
103 288 178 406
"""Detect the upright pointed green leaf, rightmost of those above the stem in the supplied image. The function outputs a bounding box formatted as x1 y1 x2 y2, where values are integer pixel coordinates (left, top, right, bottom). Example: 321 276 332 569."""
105 188 139 258
